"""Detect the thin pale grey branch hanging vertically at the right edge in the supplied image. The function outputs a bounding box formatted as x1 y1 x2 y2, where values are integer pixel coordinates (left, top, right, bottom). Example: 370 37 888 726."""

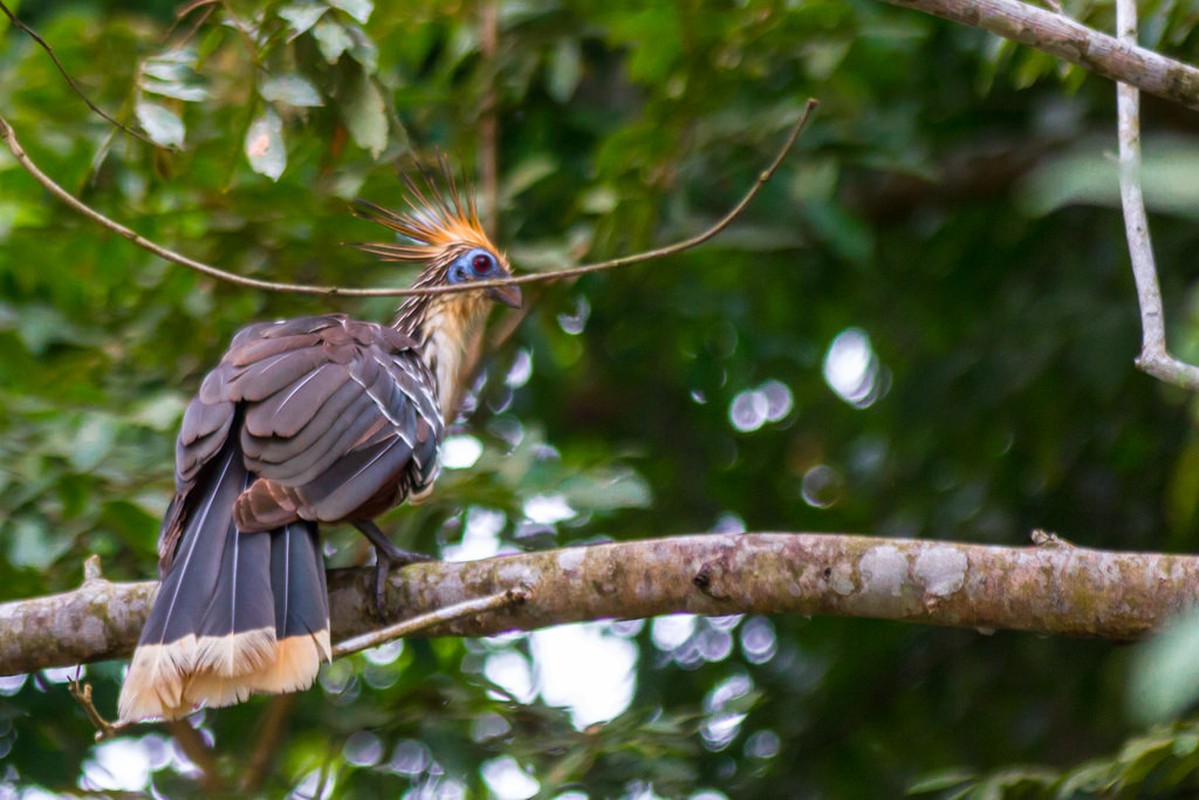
1116 0 1199 391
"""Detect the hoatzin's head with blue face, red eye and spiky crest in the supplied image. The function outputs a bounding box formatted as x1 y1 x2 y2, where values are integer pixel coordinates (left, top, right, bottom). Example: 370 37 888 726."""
355 157 522 314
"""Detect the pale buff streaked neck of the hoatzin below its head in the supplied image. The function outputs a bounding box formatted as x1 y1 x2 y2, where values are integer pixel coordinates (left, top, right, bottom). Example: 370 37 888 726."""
394 293 486 425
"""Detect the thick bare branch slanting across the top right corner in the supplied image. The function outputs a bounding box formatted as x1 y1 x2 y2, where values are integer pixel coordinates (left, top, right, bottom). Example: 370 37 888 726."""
886 0 1199 109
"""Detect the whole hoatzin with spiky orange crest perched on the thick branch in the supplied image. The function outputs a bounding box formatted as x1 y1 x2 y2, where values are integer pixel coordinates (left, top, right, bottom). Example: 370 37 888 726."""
120 162 522 721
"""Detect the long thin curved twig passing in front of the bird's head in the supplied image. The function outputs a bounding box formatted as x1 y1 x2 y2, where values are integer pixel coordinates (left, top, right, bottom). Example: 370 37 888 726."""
0 100 819 297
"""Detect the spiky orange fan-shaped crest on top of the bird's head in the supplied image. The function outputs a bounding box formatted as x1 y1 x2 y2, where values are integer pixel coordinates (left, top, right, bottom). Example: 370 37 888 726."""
354 155 502 265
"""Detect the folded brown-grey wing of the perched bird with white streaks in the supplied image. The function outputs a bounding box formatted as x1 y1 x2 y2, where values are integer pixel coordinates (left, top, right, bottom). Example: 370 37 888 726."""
161 314 442 568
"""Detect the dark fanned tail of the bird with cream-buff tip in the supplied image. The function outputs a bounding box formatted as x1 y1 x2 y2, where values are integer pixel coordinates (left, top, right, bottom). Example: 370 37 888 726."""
119 437 331 721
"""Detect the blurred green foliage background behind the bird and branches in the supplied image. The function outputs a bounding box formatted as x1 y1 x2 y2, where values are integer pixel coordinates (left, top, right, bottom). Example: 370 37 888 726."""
0 0 1199 798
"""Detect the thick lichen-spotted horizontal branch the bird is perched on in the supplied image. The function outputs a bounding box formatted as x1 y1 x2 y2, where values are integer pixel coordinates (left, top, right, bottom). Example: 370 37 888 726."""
0 534 1199 675
